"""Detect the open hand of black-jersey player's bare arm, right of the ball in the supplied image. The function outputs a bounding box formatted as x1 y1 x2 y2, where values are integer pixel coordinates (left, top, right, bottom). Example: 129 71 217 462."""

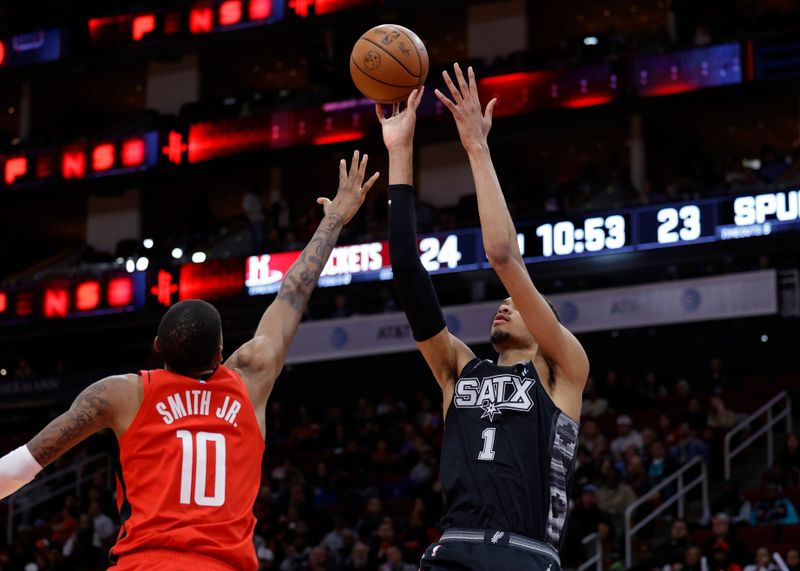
434 63 497 151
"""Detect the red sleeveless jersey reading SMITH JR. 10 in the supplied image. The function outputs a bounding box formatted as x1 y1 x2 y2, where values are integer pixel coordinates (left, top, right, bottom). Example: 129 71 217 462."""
111 366 264 571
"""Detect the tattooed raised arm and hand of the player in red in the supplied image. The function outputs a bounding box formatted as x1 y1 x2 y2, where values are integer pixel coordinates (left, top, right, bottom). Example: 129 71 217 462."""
225 151 379 406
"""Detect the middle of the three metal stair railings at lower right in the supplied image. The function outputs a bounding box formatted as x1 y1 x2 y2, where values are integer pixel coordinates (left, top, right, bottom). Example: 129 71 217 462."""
625 456 709 569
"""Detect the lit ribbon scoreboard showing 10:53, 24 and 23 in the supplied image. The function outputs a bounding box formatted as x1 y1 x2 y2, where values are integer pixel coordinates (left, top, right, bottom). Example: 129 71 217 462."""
0 190 800 325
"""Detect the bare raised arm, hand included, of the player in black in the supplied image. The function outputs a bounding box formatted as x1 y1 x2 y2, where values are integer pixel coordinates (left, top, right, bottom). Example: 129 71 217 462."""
436 64 589 413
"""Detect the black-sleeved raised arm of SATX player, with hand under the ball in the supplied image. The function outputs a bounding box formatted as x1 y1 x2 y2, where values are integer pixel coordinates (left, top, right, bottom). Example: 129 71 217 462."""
376 88 474 394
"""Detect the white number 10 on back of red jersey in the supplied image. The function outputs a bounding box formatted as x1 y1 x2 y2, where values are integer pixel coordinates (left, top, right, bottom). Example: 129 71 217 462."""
176 430 225 507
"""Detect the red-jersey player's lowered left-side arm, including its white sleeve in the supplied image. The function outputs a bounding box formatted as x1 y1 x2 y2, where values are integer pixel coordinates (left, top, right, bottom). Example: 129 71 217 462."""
0 375 141 500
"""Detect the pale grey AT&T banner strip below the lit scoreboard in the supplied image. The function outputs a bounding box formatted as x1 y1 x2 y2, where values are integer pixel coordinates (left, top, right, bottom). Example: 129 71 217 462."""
287 270 778 363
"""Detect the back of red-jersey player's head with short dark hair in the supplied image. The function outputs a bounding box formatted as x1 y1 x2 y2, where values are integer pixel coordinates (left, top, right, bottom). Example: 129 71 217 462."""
158 299 222 373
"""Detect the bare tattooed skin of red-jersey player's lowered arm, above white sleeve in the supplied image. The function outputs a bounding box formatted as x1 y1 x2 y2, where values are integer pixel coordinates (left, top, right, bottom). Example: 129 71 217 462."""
28 375 141 467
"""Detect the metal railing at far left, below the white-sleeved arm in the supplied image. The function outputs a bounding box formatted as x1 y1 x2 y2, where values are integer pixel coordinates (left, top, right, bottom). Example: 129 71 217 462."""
5 454 112 543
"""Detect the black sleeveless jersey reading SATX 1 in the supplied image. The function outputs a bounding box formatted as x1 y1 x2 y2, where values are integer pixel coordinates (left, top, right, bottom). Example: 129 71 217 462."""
440 358 578 549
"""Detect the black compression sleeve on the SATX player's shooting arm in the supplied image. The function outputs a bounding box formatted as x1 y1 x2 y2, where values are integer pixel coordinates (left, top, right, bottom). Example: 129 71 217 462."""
389 184 445 341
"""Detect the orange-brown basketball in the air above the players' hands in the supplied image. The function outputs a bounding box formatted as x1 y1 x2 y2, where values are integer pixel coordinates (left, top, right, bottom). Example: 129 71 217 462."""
350 24 428 103
